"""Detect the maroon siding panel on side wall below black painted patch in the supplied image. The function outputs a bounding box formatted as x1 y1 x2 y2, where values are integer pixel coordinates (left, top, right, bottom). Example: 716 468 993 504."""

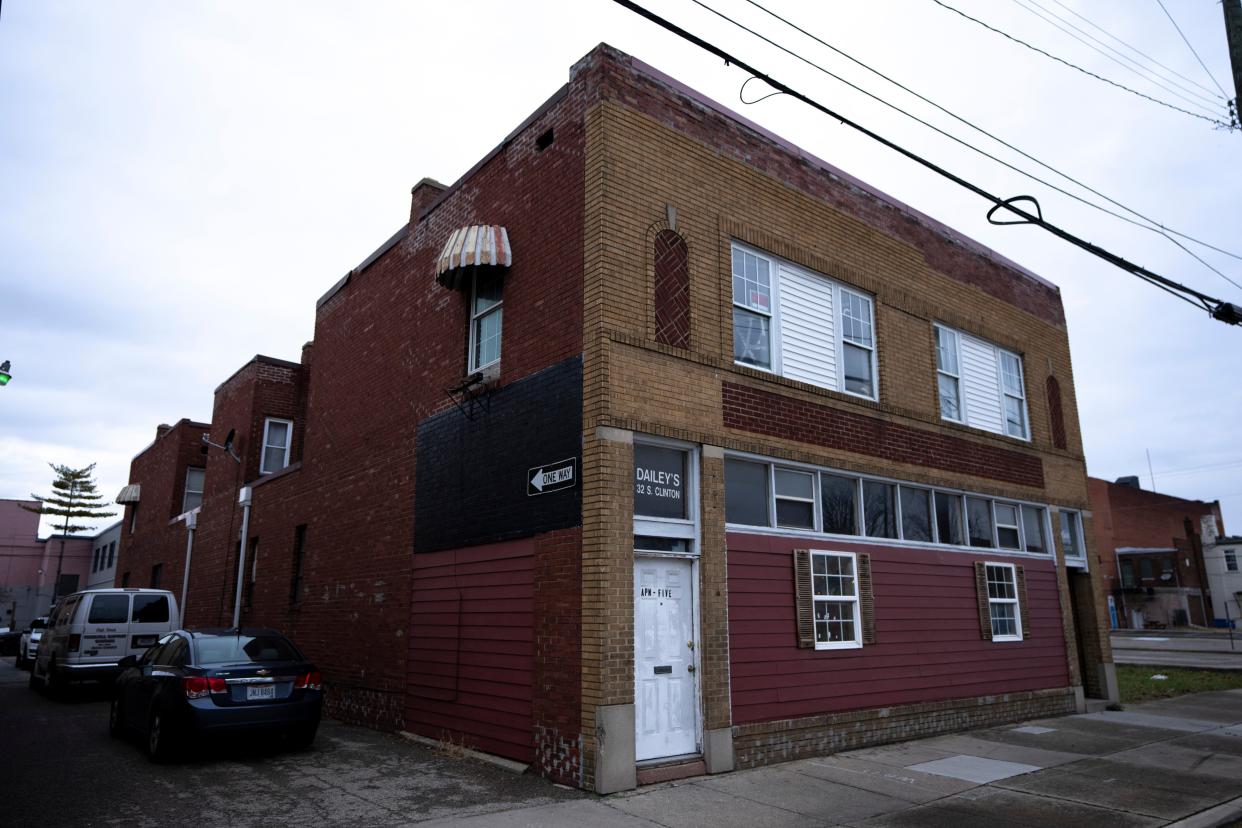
405 539 535 762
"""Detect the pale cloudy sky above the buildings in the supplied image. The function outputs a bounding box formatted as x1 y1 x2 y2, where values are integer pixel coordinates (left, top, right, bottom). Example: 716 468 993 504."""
0 0 1242 534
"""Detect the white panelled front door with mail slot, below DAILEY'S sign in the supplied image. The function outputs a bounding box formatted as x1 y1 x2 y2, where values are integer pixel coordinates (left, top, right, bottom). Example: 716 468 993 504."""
633 557 698 761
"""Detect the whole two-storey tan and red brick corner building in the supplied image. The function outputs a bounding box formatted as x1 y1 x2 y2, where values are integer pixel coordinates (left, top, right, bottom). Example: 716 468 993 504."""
120 46 1115 792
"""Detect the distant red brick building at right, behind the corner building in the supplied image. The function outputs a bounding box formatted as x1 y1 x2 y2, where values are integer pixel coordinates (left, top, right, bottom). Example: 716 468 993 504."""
1088 477 1225 629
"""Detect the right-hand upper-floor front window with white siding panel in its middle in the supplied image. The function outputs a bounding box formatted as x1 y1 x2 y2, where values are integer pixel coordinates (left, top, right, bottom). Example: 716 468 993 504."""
935 324 1031 439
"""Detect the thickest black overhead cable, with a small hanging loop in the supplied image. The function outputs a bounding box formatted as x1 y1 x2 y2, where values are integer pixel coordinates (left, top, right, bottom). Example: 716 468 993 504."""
614 0 1242 325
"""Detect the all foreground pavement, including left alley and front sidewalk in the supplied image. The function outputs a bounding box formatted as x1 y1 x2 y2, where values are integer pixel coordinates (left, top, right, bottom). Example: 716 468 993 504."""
7 659 1242 828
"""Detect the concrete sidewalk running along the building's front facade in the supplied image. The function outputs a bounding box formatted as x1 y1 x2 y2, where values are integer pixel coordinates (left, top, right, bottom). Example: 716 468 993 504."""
429 690 1242 828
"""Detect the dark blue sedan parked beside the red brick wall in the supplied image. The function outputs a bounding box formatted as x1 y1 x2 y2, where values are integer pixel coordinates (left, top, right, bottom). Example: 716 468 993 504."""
108 627 323 762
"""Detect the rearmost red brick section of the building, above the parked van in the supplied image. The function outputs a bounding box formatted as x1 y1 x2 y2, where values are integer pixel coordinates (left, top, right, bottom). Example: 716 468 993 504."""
116 420 211 600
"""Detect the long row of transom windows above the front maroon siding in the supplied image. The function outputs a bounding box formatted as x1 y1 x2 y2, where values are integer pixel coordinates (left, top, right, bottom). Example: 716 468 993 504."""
724 456 1051 554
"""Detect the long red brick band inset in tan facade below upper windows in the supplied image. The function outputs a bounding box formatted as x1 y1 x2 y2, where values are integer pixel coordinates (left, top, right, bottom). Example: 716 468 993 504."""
722 382 1043 489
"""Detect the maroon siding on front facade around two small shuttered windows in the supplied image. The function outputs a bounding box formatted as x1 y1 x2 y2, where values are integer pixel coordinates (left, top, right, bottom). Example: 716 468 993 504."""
728 533 1069 724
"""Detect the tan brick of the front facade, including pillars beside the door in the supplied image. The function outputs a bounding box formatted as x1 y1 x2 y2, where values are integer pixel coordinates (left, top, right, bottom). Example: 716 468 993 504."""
582 89 1112 784
